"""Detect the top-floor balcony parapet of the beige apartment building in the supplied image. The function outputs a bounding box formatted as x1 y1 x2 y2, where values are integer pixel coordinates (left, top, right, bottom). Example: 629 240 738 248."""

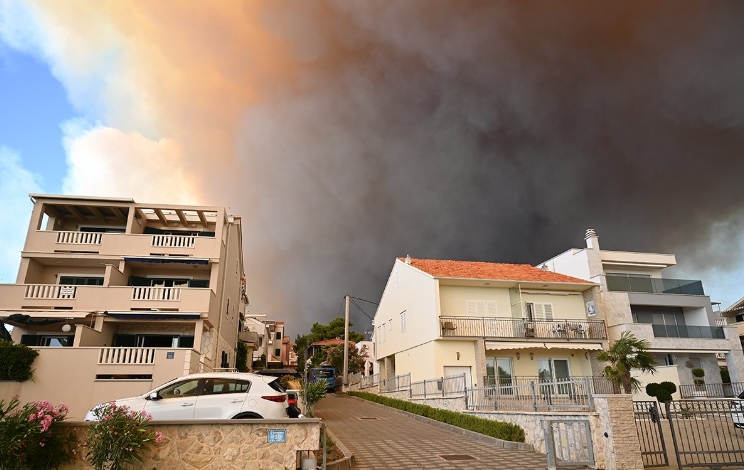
24 230 220 258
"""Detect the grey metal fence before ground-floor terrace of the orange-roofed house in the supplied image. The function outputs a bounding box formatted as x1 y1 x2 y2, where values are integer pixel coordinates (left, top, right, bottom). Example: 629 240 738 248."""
466 377 594 411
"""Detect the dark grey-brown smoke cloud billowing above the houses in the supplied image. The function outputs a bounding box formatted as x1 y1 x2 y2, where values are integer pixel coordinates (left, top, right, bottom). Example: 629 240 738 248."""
225 0 744 334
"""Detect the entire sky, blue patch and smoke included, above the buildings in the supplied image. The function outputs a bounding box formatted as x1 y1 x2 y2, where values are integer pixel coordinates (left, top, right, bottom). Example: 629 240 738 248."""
0 0 744 335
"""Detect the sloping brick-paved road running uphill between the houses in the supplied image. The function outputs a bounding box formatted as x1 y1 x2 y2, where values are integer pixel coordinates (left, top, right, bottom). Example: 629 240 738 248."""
315 395 547 470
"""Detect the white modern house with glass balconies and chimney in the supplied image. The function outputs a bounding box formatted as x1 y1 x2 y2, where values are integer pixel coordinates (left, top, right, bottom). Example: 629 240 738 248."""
540 229 744 396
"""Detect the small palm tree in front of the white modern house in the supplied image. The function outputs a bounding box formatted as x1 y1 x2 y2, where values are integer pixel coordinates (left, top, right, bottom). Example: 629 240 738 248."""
597 331 656 393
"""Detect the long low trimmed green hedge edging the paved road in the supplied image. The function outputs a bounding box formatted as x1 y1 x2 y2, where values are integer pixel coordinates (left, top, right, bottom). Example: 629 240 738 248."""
349 392 525 442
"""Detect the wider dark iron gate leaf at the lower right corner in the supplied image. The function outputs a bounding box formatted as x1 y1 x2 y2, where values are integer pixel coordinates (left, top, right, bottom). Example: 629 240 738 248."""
665 399 744 469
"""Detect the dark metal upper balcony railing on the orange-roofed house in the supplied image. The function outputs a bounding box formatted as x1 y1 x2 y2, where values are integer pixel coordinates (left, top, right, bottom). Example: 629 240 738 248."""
440 317 607 339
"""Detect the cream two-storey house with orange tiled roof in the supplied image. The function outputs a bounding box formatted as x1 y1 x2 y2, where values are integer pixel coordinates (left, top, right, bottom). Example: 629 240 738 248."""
374 257 607 387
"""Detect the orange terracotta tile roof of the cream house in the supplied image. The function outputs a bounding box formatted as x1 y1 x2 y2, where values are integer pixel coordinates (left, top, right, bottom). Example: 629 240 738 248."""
398 258 593 284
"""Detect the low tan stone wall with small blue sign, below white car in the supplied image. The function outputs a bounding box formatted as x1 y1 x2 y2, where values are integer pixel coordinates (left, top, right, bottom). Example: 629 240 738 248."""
61 418 321 470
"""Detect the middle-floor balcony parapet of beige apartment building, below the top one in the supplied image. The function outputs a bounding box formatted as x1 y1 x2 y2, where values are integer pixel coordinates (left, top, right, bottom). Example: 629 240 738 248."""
0 284 216 312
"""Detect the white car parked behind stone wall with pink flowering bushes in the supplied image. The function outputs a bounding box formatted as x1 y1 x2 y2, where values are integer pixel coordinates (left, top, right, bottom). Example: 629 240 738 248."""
85 372 292 421
